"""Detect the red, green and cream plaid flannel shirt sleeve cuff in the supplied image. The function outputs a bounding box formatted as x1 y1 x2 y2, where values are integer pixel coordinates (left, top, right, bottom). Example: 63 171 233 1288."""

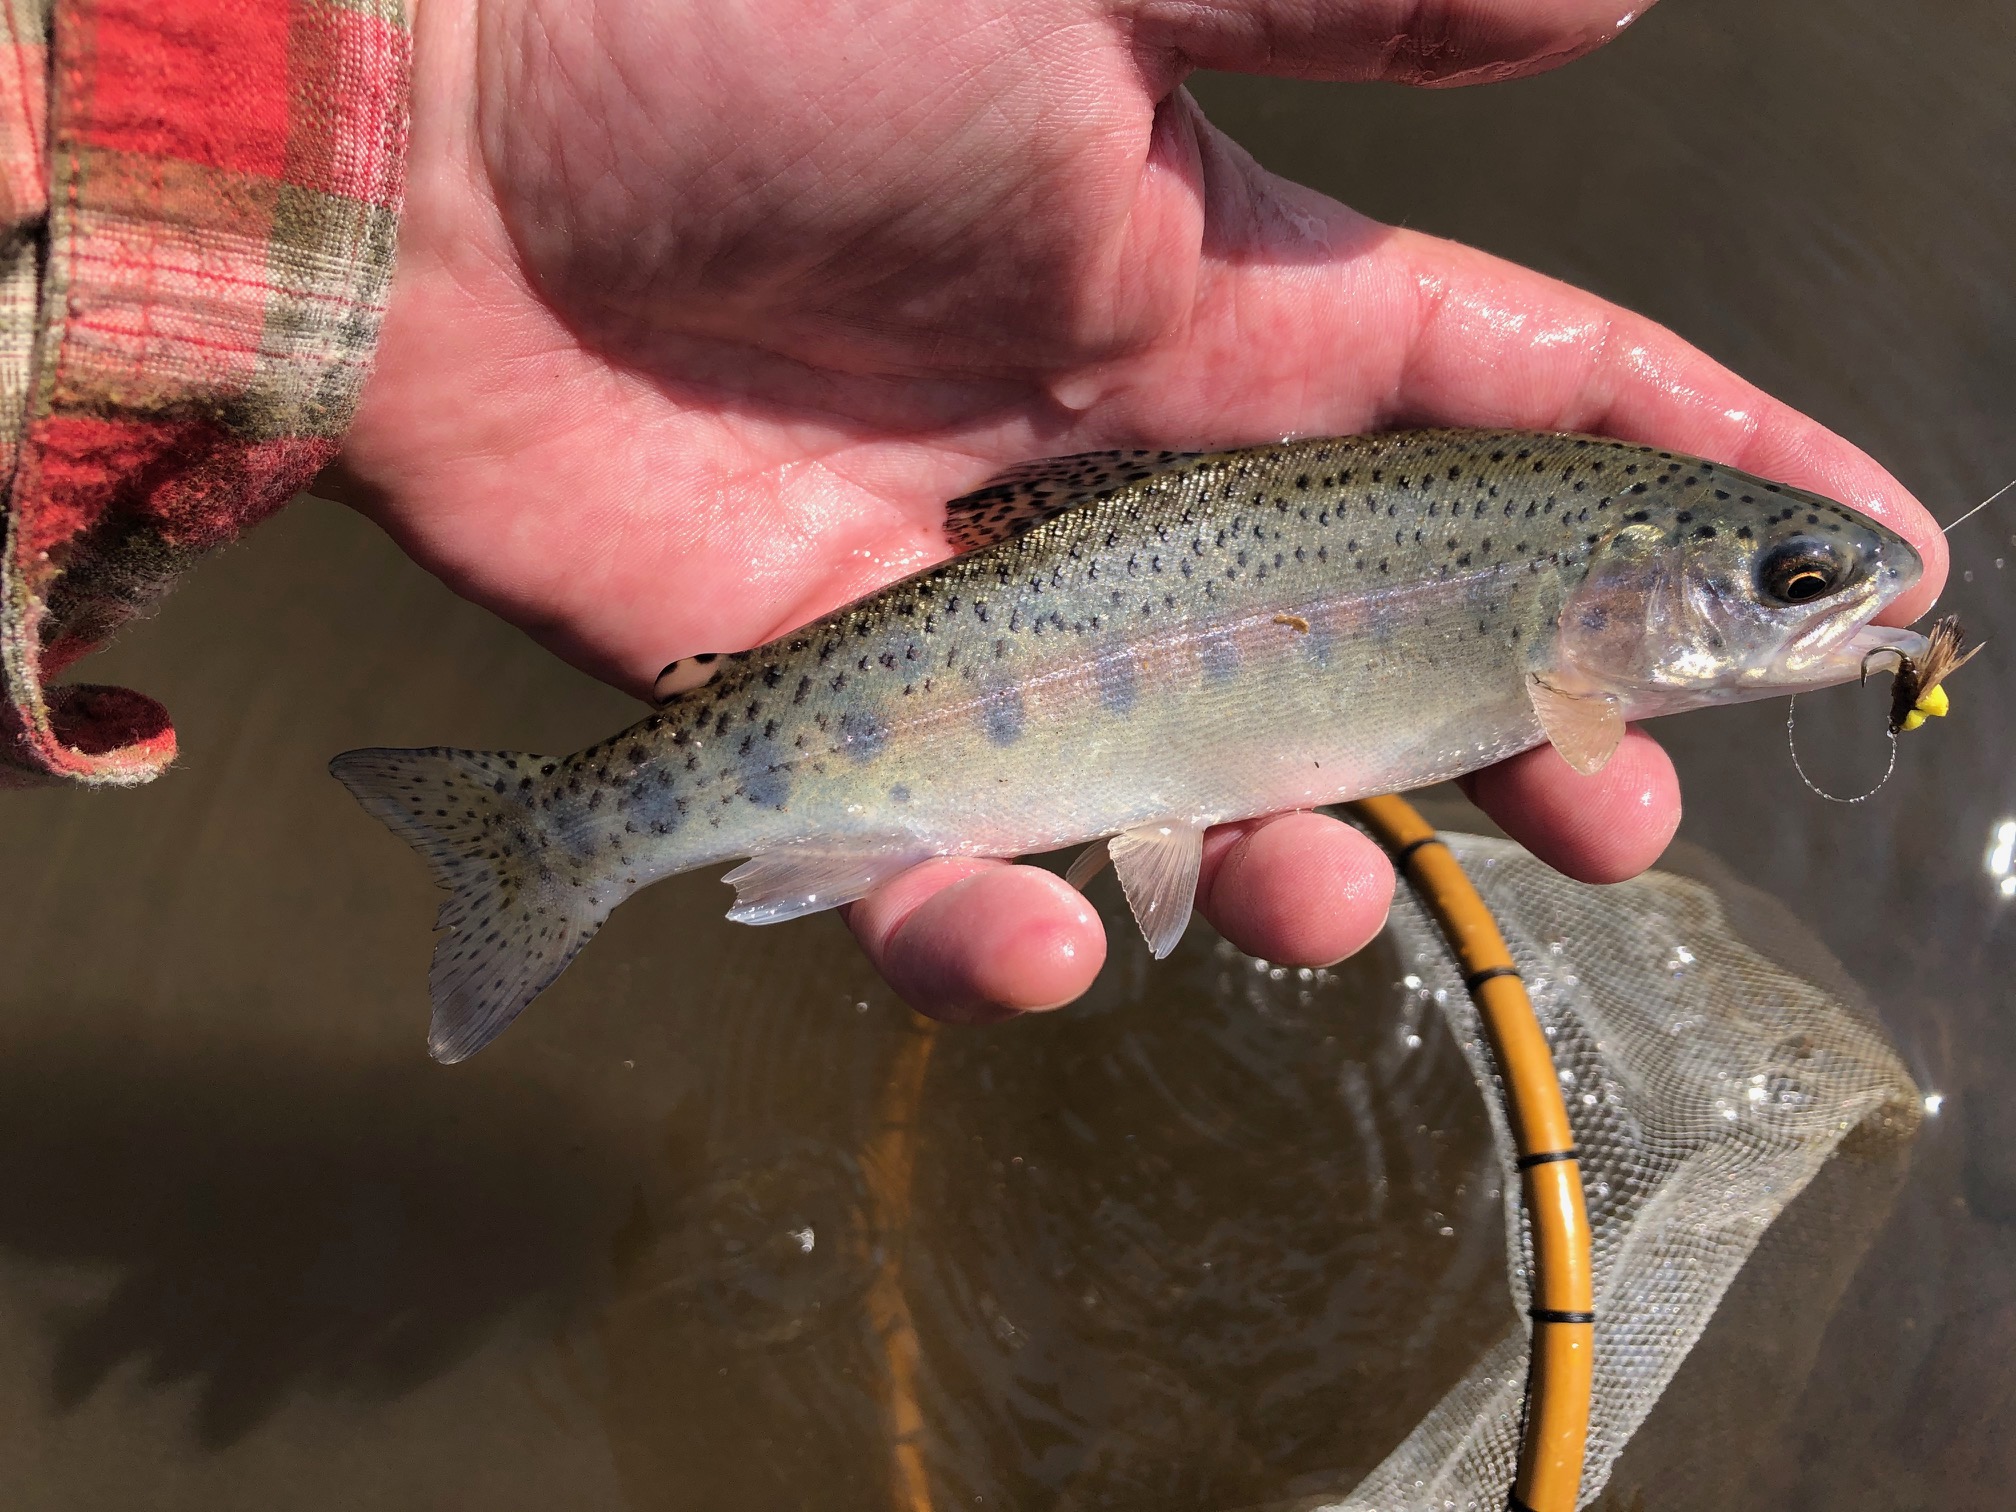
0 0 411 786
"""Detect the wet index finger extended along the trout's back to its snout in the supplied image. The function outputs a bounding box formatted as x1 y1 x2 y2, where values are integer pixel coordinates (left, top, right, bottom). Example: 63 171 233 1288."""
1087 121 1945 625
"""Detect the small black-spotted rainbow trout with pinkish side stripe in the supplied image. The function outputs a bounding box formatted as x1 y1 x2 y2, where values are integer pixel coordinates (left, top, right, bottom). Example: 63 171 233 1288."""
331 431 1923 1060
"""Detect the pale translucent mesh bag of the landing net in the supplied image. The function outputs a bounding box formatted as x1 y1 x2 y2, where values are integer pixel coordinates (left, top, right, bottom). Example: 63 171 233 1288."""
1308 835 1919 1512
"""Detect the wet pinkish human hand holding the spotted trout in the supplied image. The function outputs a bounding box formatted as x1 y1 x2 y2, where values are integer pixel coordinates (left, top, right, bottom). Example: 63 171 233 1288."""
345 0 1945 1018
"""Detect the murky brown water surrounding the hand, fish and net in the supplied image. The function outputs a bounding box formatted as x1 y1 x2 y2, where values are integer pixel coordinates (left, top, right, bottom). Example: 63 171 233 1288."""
0 0 2016 1512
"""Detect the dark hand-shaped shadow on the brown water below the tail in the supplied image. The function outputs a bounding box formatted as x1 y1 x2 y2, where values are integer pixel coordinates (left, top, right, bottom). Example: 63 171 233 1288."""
0 1024 625 1447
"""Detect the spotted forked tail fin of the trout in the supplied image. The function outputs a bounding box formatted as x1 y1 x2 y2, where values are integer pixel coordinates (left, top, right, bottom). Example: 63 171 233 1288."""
329 746 627 1062
